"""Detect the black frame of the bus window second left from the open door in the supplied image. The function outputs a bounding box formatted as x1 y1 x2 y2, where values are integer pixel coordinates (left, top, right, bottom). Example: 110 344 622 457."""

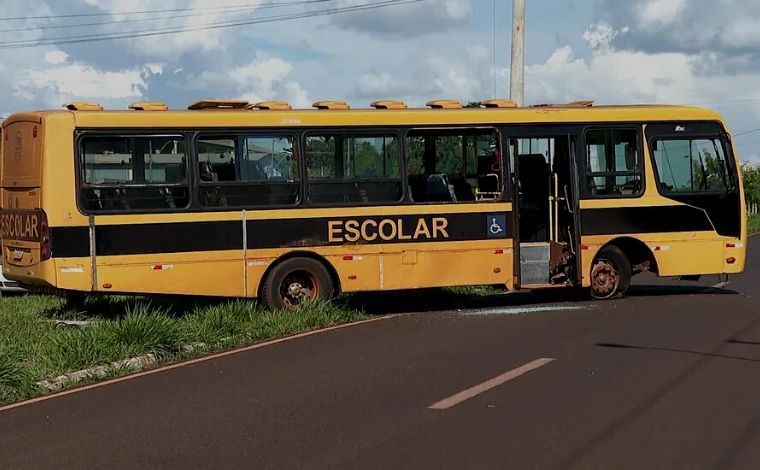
299 126 408 208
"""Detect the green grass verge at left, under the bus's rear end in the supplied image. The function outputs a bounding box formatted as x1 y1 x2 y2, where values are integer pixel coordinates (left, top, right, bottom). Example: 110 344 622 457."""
0 295 367 405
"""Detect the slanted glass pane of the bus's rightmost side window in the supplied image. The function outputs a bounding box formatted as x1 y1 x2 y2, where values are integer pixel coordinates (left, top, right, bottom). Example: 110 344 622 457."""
652 138 734 193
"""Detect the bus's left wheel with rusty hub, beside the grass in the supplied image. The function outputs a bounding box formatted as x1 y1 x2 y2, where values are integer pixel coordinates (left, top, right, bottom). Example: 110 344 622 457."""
261 257 335 310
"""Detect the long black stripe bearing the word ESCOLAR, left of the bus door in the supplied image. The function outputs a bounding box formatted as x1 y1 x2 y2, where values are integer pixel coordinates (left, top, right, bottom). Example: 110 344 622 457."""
51 212 513 258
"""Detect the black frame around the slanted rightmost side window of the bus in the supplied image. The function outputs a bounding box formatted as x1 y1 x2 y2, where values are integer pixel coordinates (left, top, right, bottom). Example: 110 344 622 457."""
645 121 739 198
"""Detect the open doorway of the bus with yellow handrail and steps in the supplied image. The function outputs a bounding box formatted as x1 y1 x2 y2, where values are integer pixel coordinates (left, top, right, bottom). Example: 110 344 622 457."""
506 128 579 288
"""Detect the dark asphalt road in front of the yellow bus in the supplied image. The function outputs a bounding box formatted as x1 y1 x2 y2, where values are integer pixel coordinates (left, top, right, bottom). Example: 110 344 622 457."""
0 240 760 469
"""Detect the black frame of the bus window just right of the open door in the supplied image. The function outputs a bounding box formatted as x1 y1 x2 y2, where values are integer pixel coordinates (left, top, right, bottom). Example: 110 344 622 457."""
576 123 647 200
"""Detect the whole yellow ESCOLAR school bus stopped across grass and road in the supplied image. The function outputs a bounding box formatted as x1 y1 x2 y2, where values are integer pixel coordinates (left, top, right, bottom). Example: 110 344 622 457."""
1 100 747 308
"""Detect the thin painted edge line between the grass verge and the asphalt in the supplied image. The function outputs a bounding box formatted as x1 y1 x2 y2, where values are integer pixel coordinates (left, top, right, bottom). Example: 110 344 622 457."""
0 314 403 413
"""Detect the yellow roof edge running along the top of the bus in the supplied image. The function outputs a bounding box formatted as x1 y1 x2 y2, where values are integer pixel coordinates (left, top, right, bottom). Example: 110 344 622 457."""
3 105 723 128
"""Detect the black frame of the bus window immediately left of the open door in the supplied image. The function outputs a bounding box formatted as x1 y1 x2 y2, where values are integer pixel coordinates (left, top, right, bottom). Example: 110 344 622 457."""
402 123 512 206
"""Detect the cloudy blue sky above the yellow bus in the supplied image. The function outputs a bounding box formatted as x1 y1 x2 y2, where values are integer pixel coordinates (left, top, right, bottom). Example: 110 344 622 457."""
0 0 760 163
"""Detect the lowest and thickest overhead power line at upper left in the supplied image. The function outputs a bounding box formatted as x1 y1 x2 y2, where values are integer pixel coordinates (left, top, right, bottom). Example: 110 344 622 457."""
0 0 425 49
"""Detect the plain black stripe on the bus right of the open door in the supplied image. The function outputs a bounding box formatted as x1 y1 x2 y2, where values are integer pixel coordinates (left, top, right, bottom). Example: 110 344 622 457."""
581 206 714 235
